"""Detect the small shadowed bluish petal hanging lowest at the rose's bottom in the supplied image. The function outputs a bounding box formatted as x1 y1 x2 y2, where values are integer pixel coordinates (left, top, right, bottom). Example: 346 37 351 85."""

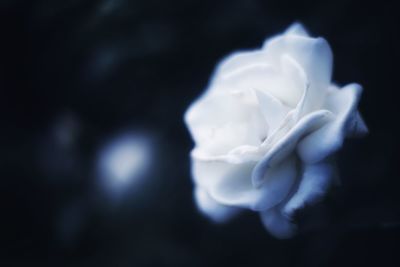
260 207 297 238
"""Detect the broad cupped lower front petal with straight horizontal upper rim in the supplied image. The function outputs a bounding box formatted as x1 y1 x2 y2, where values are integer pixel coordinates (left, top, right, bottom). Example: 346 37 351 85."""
193 158 296 210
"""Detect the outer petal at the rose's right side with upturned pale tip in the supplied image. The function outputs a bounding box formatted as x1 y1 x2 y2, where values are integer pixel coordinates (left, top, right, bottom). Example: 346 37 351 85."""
297 84 362 163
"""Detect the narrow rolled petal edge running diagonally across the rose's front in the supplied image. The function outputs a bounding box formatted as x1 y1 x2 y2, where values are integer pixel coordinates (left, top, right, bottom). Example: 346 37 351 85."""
252 110 332 187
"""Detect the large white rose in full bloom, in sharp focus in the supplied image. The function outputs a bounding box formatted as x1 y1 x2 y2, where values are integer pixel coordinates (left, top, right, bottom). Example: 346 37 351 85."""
185 24 367 238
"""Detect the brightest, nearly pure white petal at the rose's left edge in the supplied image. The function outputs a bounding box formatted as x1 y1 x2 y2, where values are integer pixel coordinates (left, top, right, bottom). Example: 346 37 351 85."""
185 93 267 155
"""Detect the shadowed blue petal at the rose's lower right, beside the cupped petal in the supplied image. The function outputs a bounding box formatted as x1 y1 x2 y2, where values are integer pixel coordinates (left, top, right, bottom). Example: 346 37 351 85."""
283 162 334 217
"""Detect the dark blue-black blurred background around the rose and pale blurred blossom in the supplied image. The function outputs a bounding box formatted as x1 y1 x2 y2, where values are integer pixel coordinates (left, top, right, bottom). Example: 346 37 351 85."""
0 0 400 266
